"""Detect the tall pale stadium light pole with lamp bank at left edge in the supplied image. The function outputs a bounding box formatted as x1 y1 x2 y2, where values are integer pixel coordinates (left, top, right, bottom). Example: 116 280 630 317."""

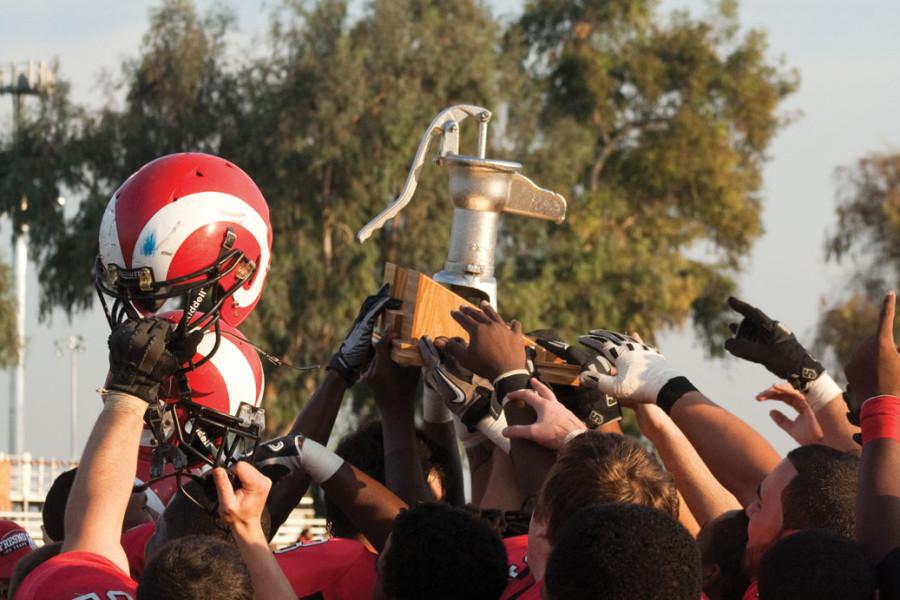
0 60 53 455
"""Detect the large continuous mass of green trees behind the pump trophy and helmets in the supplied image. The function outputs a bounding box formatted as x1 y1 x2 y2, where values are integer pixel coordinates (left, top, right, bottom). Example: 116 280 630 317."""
0 0 795 426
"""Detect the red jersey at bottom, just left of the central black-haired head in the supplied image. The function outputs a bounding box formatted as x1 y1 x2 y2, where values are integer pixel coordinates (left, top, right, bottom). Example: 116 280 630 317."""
275 538 377 600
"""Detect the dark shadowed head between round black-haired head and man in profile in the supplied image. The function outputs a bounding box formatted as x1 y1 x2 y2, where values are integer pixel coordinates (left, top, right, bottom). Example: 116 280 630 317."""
697 510 750 600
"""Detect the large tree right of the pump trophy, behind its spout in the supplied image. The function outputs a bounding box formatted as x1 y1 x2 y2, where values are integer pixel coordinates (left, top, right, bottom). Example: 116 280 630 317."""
499 0 796 353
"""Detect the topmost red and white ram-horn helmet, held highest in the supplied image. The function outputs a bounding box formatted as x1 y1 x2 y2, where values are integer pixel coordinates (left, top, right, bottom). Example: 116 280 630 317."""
95 152 272 328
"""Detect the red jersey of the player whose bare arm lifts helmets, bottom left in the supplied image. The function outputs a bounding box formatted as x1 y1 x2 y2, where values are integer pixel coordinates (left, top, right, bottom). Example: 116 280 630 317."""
16 552 137 600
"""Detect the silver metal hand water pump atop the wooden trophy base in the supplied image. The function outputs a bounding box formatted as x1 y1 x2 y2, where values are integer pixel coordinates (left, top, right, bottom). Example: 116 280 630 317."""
356 104 566 307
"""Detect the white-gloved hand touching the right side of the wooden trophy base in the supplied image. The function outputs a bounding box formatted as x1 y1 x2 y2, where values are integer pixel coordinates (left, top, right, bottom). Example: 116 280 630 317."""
578 329 695 406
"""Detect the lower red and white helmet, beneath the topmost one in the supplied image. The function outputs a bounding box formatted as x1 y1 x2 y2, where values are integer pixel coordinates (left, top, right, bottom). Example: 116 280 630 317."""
141 310 265 477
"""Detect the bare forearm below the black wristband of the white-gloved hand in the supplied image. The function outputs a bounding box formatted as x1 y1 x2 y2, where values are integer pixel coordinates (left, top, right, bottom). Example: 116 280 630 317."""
670 392 780 506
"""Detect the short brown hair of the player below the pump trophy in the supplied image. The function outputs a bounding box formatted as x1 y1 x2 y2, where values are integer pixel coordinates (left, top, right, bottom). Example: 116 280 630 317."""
534 430 678 544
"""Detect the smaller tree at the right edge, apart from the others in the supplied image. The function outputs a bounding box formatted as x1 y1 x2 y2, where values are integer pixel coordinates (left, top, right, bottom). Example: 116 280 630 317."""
816 153 900 373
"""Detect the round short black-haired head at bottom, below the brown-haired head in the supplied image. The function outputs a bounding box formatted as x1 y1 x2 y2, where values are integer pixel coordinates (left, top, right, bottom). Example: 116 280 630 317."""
544 504 702 600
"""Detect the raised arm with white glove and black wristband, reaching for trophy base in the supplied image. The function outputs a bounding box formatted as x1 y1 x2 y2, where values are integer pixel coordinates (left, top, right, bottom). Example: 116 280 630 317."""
581 329 780 506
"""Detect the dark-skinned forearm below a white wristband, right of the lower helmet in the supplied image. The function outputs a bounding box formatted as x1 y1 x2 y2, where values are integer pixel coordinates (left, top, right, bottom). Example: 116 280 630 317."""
321 462 407 551
